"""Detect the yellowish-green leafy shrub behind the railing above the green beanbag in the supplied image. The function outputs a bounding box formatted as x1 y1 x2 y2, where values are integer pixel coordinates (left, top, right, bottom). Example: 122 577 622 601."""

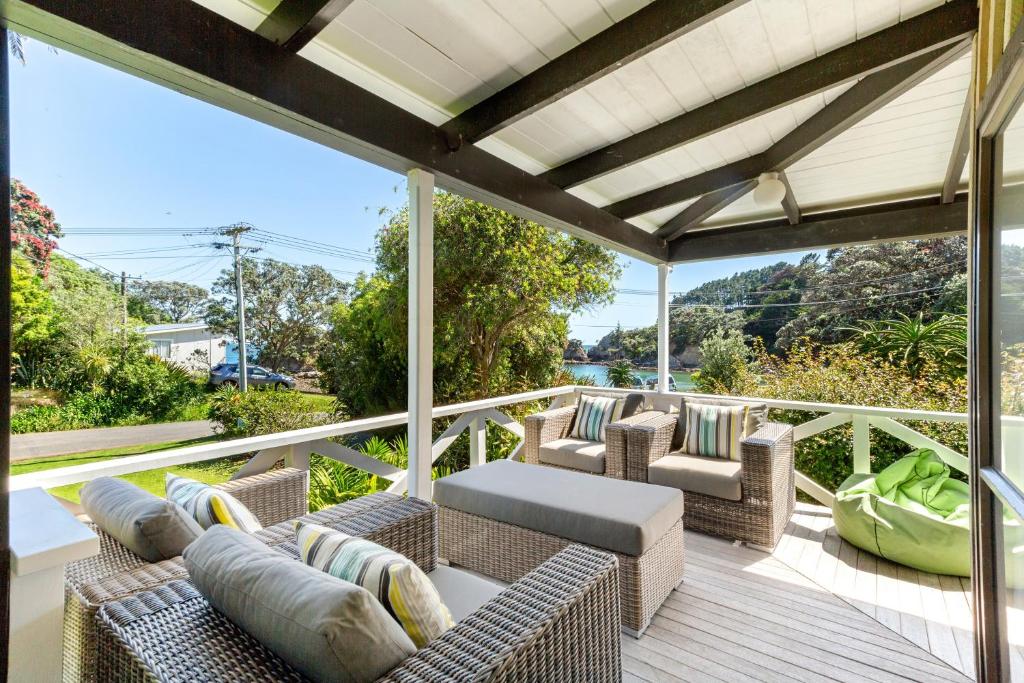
733 341 967 490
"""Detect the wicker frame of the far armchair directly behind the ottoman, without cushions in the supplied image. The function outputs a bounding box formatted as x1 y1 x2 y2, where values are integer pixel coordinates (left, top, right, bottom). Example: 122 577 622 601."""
522 405 665 479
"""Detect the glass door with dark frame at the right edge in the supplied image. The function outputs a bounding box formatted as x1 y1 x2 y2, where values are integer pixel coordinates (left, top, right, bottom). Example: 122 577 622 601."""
971 38 1024 683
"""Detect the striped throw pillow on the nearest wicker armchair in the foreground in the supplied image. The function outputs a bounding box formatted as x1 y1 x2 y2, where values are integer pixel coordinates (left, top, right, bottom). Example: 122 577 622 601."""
294 520 455 647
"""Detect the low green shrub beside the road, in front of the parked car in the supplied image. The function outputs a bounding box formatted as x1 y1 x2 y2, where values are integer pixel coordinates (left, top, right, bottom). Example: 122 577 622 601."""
210 387 337 436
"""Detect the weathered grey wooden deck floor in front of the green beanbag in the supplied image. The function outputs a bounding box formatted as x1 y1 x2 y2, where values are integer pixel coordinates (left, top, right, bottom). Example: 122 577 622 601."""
623 505 1019 681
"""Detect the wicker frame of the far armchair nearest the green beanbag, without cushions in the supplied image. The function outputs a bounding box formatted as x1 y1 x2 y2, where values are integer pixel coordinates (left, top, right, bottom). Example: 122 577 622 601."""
626 415 796 548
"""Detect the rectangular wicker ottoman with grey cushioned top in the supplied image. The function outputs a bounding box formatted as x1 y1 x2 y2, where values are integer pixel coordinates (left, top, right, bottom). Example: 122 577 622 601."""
434 461 683 637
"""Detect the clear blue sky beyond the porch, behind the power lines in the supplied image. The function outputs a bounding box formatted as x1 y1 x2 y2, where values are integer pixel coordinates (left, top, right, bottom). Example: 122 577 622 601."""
10 41 802 343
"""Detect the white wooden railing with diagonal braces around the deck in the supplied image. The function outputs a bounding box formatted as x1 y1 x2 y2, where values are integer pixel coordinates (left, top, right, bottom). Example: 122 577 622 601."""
10 386 968 505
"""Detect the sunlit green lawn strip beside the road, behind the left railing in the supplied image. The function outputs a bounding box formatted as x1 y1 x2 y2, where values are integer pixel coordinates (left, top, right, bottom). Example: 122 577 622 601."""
10 436 248 503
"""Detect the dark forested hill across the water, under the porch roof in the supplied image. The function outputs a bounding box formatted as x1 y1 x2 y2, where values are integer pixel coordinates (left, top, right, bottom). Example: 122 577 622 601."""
577 237 974 362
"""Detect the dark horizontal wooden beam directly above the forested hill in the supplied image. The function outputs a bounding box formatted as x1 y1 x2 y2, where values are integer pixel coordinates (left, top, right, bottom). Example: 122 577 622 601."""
669 197 968 263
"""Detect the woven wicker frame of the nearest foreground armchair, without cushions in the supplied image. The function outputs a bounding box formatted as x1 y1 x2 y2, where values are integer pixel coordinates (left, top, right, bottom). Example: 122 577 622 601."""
97 501 622 682
